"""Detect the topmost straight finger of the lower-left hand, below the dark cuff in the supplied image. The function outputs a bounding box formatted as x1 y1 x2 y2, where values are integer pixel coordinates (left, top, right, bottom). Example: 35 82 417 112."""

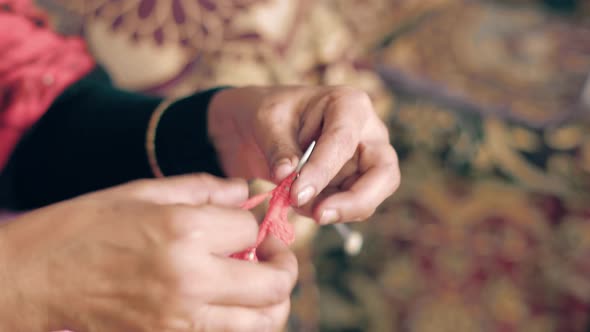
122 173 248 206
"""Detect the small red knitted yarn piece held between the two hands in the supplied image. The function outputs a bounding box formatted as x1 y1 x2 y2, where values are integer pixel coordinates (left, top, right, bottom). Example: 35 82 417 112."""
231 172 297 261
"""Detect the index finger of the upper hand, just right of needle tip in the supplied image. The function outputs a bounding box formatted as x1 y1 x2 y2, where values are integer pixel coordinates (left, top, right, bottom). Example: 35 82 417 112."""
291 89 372 206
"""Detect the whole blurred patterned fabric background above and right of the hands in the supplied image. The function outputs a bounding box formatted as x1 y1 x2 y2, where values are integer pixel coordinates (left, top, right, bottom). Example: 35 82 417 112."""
39 0 590 332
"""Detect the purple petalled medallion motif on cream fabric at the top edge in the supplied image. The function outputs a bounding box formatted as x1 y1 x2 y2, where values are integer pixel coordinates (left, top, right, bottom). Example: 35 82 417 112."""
57 0 262 49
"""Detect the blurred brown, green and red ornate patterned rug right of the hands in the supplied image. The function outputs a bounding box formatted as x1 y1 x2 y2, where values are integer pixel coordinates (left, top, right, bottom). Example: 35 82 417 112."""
301 1 590 332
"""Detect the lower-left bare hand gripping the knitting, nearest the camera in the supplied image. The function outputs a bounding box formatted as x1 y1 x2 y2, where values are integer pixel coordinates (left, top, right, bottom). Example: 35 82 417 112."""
0 175 297 332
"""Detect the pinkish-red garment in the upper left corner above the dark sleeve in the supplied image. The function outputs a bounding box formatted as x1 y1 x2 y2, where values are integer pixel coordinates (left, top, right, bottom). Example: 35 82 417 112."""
0 0 94 170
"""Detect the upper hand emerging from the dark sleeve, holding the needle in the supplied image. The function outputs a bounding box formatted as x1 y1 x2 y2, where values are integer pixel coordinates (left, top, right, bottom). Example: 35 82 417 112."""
208 87 400 224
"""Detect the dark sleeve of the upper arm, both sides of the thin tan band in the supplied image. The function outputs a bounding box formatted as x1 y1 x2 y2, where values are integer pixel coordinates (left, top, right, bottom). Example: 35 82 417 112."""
0 69 227 210
